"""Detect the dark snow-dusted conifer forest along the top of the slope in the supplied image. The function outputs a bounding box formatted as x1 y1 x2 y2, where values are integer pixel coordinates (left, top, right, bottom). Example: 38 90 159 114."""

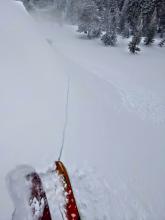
22 0 165 53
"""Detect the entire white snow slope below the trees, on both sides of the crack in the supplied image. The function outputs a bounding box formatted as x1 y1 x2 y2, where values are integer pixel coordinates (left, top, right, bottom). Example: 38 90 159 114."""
0 0 165 220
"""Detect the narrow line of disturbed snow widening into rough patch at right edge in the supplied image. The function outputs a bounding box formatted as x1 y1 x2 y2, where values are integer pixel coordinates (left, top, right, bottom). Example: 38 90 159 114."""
46 32 165 124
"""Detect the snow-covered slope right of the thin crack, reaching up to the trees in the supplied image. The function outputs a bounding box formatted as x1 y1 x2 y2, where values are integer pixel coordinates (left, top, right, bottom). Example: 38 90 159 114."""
37 23 165 219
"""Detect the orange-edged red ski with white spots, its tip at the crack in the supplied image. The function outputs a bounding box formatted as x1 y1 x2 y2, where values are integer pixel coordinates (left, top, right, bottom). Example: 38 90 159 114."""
55 161 80 220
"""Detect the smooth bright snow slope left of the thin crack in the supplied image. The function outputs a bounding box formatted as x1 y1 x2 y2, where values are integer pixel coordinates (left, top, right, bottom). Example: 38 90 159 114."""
0 0 67 220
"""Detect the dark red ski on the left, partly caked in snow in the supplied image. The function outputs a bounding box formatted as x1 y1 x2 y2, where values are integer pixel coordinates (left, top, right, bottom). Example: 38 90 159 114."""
26 172 52 220
